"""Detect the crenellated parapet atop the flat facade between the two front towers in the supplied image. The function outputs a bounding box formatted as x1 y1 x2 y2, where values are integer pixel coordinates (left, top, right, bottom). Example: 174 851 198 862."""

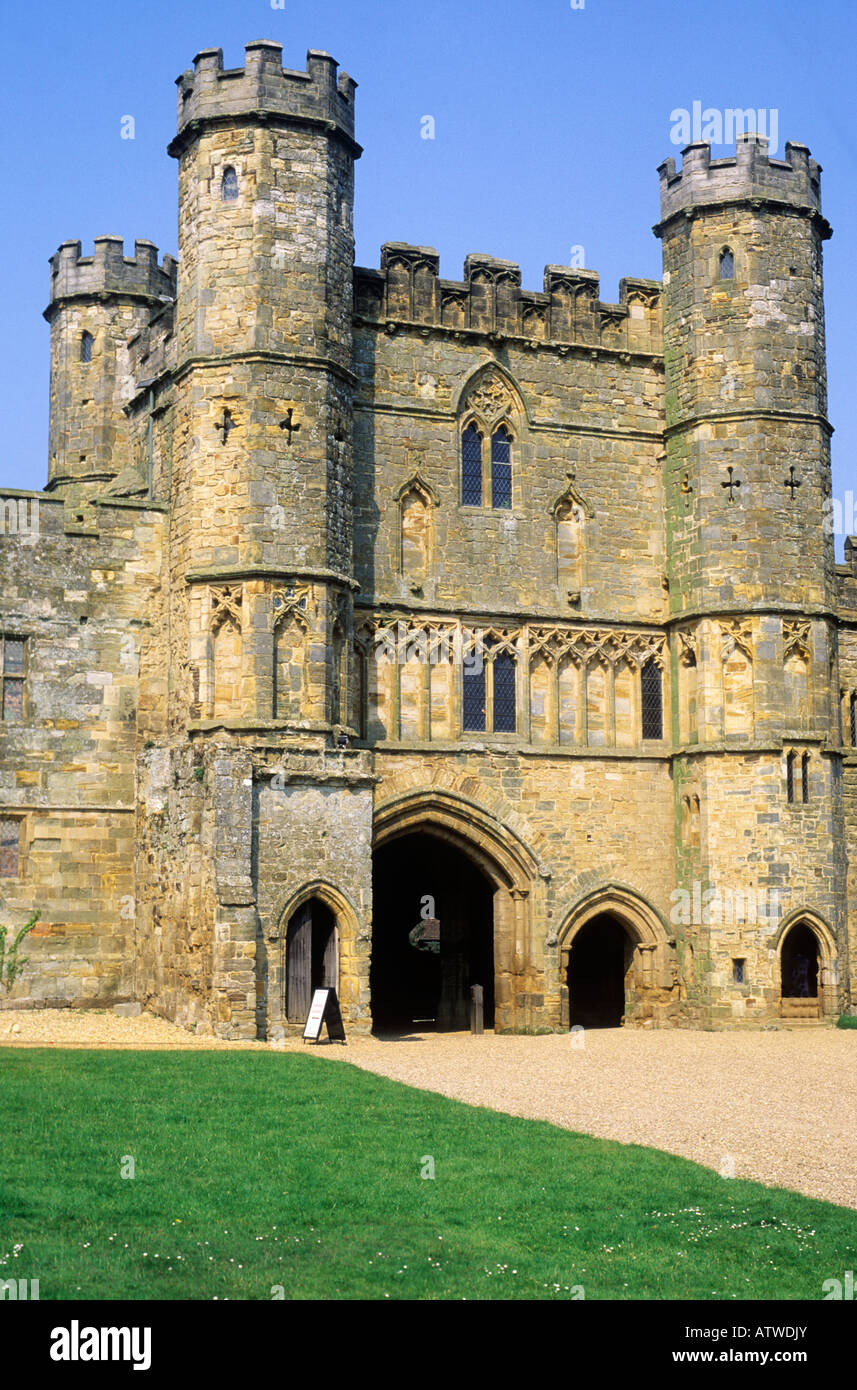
354 242 663 356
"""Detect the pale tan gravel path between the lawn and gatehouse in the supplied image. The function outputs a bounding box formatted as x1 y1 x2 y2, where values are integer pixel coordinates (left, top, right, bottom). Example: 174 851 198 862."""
0 1009 857 1208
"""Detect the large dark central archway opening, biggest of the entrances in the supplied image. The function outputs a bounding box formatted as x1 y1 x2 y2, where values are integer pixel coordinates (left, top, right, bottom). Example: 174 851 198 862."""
369 830 496 1031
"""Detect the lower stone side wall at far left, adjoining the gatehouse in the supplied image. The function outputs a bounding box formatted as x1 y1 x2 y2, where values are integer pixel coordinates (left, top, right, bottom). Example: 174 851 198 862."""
0 492 163 1005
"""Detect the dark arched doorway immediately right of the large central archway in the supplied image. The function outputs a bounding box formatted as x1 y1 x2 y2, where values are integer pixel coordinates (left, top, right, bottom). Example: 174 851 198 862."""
568 912 635 1029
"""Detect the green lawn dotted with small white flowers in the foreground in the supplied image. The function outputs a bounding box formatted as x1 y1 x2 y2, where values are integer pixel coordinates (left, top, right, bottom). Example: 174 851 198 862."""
0 1049 857 1300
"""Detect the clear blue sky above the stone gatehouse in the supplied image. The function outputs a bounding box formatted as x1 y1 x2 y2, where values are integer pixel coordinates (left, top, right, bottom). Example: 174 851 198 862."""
0 0 857 553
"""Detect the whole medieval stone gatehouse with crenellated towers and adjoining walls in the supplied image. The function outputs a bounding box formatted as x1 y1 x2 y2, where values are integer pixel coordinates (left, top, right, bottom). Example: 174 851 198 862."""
0 42 857 1038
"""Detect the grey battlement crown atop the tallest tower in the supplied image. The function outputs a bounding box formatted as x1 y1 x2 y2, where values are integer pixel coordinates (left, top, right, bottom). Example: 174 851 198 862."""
168 39 357 158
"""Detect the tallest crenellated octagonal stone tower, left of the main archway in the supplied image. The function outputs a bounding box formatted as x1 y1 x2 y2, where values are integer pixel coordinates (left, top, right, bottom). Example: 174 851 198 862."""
169 40 360 734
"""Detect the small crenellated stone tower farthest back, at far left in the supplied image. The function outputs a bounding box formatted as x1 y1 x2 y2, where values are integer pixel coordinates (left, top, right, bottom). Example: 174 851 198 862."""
44 236 176 502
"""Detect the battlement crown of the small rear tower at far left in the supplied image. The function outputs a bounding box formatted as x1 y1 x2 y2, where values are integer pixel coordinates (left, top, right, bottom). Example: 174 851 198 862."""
50 236 176 306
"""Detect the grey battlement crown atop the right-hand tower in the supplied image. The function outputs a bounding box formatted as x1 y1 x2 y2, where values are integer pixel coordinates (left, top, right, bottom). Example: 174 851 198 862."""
656 132 821 231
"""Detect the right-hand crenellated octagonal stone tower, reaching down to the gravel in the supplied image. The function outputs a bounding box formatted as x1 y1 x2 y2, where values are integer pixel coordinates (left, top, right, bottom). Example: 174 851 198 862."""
654 135 842 1022
